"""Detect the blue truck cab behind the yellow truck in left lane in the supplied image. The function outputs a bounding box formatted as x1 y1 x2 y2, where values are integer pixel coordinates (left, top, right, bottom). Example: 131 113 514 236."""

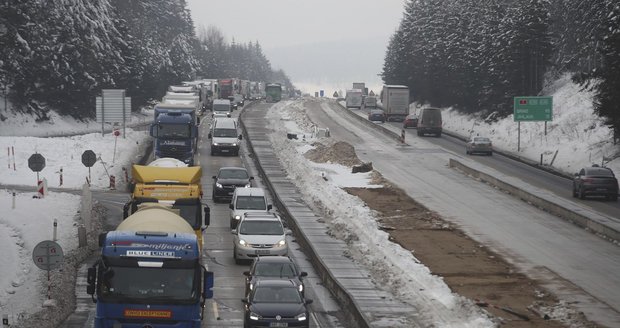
150 103 198 166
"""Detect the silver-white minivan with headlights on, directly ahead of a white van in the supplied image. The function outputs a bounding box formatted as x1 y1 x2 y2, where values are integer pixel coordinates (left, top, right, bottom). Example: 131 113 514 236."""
232 212 291 264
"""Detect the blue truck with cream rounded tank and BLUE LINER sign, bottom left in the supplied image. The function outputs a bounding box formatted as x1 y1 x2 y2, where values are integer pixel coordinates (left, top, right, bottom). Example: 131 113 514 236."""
87 204 214 328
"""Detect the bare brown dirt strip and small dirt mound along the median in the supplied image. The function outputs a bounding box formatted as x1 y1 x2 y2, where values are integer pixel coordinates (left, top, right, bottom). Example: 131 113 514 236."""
306 142 598 328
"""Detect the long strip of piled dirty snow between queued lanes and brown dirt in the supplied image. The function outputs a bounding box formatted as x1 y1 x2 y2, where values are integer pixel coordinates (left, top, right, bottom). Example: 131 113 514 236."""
267 101 494 327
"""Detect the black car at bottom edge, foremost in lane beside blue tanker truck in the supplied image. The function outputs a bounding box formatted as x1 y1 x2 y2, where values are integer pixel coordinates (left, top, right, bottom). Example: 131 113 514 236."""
241 279 312 328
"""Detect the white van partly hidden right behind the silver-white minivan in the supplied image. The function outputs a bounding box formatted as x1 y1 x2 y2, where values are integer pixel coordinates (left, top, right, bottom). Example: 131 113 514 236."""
228 187 272 229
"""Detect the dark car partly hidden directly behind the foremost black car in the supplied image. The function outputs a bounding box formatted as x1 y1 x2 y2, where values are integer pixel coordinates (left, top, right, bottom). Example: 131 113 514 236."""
243 256 308 296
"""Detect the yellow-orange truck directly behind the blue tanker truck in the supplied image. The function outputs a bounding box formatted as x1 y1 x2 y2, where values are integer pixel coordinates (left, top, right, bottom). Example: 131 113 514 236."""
123 158 211 248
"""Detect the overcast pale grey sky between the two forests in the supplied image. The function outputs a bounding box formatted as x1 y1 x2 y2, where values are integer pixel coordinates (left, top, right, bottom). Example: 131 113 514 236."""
187 0 405 92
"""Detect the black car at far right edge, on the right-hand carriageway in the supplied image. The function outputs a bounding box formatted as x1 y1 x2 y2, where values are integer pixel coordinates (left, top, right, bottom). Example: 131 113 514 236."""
573 165 618 201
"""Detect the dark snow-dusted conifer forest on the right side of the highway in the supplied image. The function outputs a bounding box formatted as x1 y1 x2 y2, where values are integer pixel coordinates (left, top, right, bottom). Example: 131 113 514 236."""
382 0 620 131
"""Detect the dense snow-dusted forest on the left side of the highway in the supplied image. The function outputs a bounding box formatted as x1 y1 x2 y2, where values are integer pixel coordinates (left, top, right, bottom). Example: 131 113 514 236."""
0 0 290 119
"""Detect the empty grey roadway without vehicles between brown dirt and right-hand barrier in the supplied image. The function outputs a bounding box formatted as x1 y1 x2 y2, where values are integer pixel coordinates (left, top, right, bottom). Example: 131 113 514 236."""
306 101 620 326
